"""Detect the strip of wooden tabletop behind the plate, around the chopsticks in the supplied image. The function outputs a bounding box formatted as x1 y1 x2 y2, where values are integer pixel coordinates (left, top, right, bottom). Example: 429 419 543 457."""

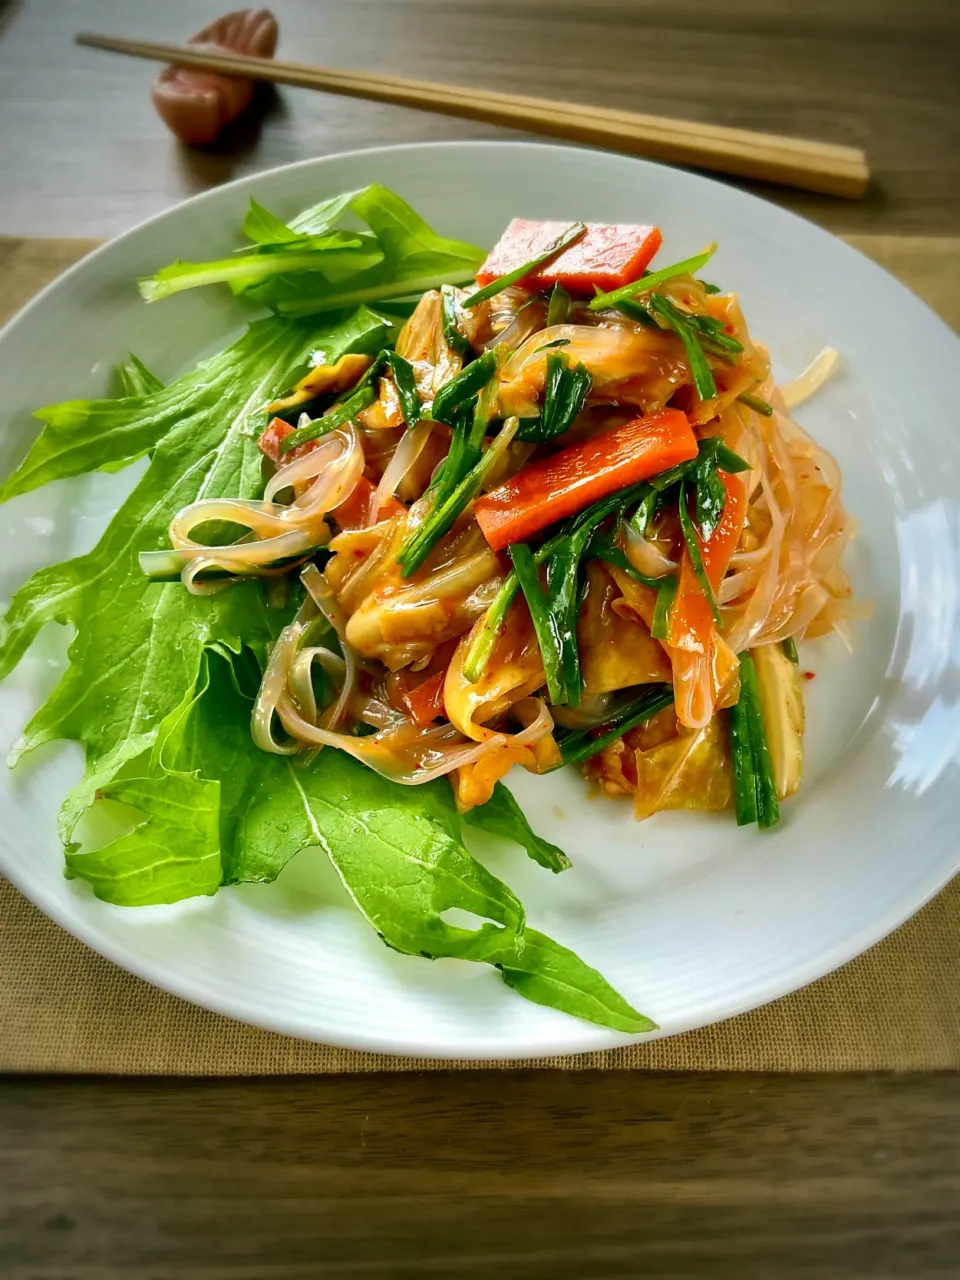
0 0 960 236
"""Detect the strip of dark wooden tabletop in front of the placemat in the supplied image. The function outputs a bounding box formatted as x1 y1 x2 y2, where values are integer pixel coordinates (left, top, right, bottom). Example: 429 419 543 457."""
0 1071 960 1280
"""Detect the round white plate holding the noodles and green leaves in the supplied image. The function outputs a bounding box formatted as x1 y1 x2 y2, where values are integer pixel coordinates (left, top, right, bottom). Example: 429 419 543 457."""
0 142 960 1059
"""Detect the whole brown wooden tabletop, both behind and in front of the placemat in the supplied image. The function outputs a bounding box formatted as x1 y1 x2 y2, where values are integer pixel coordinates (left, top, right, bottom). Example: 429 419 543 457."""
0 0 960 1280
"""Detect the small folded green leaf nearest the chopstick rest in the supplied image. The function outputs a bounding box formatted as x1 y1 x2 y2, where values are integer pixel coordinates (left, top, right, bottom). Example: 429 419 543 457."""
140 184 485 316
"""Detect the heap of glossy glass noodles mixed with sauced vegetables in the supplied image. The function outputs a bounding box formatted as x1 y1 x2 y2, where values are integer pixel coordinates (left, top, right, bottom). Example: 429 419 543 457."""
145 220 867 826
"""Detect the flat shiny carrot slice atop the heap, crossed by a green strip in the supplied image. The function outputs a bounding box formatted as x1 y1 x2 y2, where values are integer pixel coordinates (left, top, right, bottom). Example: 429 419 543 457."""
476 218 662 298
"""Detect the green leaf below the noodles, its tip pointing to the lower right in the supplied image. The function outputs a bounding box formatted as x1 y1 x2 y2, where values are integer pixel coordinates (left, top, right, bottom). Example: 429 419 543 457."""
68 649 654 1033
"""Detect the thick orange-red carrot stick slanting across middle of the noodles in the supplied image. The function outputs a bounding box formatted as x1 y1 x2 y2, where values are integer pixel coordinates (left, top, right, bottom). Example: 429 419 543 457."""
475 408 698 550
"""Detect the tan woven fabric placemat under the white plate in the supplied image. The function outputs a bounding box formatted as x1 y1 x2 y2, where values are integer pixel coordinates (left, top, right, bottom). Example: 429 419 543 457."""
0 236 960 1075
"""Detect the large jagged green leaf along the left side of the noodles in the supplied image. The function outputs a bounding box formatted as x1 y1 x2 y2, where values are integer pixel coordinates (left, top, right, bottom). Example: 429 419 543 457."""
0 312 384 847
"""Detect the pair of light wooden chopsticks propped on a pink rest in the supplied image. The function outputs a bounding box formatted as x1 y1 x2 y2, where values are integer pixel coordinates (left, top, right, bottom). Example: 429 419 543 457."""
77 32 870 200
